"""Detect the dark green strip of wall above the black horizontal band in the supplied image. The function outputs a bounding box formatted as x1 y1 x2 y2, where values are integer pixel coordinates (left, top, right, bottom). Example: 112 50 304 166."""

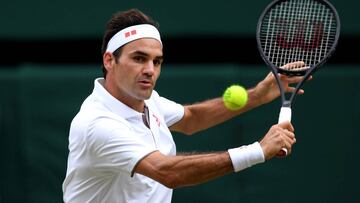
0 0 360 39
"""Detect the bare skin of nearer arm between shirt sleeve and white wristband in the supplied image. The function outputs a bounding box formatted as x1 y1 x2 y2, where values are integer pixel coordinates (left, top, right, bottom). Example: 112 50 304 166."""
135 152 234 188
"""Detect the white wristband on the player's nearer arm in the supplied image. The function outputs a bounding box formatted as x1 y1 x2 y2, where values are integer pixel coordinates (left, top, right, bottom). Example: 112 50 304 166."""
228 142 265 172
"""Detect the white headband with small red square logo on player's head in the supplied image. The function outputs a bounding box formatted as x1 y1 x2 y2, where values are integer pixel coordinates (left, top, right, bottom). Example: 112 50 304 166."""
106 24 162 53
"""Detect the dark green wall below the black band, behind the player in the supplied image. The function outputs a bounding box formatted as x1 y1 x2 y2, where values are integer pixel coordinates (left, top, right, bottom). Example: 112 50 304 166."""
0 64 360 203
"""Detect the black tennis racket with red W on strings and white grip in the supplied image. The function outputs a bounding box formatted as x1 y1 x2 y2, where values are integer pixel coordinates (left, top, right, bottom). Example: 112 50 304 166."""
256 0 340 156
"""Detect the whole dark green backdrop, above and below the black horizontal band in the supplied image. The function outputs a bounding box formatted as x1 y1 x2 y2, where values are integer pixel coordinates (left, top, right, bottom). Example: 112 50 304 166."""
0 0 360 203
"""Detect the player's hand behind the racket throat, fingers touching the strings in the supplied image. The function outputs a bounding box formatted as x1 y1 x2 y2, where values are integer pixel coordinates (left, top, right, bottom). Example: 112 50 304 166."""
254 61 312 104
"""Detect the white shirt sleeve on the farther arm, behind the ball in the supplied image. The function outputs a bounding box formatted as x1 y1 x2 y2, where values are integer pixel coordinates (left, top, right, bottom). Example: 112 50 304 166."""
152 91 185 127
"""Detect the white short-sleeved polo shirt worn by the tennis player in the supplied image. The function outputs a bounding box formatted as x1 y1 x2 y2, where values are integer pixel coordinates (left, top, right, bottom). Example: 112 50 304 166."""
63 78 184 203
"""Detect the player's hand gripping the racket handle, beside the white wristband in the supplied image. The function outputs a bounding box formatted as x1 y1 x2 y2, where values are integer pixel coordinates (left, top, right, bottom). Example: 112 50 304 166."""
260 121 296 160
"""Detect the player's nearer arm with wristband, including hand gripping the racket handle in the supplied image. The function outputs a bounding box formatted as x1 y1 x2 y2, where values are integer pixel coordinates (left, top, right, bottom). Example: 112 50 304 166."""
134 122 295 188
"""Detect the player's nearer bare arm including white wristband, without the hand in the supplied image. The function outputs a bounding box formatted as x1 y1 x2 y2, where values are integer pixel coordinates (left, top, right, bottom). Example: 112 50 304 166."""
135 143 264 188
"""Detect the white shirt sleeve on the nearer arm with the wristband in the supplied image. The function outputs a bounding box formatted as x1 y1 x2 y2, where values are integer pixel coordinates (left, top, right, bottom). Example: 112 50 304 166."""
86 117 156 175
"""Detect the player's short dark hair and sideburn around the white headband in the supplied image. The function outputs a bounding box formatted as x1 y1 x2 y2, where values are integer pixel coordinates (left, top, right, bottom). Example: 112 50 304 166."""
101 9 159 78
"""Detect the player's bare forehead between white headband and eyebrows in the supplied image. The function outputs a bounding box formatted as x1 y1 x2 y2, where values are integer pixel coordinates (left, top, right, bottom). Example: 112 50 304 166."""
122 38 163 57
